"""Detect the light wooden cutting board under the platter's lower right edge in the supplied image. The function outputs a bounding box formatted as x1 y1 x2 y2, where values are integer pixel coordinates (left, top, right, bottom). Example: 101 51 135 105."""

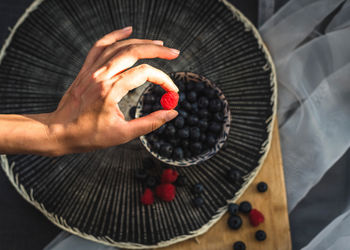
162 121 292 250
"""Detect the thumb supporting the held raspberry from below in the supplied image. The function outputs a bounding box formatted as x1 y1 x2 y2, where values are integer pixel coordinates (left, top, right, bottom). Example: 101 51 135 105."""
127 110 178 140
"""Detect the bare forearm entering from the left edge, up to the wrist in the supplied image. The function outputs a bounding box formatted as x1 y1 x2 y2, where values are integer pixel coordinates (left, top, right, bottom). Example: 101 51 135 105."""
0 114 58 155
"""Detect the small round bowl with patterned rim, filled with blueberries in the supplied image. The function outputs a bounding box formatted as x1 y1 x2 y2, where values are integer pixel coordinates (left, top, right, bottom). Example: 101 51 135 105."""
135 72 231 166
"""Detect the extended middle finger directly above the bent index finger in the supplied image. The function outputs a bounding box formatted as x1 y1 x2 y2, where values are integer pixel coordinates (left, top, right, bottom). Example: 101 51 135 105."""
93 44 180 80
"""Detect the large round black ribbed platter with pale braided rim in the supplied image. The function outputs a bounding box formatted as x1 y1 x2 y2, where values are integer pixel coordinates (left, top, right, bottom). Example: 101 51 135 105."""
0 0 276 248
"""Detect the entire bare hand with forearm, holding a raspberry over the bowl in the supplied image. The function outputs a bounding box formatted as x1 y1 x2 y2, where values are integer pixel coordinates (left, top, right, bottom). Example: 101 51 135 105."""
0 27 179 156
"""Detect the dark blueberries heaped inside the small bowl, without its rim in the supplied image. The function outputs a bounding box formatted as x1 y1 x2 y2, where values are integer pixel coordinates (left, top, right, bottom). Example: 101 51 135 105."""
141 76 225 160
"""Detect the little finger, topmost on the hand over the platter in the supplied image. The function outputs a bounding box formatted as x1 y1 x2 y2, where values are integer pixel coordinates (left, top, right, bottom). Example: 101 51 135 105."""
83 26 132 68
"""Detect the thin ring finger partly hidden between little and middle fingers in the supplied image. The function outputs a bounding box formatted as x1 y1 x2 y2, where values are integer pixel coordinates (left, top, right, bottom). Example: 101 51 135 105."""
92 39 163 71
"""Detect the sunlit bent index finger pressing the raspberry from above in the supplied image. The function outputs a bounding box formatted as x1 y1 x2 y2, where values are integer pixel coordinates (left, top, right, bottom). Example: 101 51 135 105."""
109 64 179 103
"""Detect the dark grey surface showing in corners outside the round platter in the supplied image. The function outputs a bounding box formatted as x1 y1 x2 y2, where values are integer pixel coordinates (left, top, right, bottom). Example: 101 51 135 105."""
0 0 258 250
